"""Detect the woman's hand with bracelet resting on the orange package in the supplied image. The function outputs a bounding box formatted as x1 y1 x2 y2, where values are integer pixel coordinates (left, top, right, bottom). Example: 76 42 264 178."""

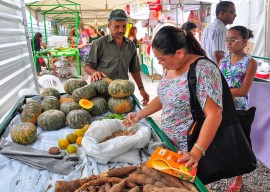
177 151 202 168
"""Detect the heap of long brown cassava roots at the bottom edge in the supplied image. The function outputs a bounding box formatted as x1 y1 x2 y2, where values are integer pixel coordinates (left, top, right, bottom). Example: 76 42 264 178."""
55 166 197 192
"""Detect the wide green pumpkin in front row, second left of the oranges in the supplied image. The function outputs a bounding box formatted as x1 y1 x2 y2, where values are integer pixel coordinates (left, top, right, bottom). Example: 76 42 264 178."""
37 109 66 131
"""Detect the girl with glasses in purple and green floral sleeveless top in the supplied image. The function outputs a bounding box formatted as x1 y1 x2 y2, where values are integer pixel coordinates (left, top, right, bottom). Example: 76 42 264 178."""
219 26 257 192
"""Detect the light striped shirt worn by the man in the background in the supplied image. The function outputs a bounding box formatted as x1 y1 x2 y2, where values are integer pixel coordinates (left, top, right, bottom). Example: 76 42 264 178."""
202 18 228 63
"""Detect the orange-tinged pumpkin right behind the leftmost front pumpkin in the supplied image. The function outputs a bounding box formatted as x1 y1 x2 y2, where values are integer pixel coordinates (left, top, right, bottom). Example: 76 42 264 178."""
21 100 42 124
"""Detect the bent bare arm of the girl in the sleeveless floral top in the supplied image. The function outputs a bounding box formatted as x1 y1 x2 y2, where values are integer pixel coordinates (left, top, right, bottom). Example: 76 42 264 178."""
230 58 257 97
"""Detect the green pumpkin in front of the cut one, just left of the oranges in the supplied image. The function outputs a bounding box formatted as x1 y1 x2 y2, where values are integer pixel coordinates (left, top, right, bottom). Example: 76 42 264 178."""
66 109 91 129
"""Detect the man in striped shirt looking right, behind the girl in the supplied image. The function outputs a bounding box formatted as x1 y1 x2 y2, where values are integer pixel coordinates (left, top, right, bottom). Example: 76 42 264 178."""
202 1 236 64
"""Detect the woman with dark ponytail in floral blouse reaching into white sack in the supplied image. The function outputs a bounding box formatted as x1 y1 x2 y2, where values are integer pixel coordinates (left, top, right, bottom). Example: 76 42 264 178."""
123 26 222 180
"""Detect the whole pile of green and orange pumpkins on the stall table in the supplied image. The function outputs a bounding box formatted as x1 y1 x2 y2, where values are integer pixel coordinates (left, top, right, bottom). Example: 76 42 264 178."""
11 78 135 145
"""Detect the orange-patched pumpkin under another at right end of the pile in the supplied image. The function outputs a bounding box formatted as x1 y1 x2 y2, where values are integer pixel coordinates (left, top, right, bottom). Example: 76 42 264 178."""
108 96 134 114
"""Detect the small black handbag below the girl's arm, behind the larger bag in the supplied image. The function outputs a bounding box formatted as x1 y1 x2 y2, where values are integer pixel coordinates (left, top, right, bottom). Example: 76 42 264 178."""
236 107 256 146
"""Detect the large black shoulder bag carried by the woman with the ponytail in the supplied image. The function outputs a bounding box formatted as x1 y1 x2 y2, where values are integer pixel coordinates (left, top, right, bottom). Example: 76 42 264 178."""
187 58 256 184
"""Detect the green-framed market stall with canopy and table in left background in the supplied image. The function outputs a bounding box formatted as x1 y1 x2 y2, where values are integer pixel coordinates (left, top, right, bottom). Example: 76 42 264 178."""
27 1 81 77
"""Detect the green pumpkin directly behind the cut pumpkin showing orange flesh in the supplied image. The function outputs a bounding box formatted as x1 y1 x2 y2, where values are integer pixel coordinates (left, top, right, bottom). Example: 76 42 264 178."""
72 85 96 103
